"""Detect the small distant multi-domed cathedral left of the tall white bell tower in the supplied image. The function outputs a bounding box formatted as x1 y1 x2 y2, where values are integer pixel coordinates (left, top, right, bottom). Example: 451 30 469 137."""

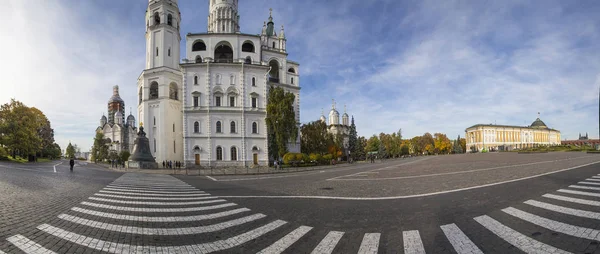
96 86 137 153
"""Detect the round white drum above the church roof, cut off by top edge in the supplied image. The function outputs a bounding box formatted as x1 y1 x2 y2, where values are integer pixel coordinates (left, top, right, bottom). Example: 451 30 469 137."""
208 0 240 33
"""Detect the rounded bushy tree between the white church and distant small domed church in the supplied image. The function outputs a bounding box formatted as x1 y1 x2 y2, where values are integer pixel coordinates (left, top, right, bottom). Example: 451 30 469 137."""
300 121 333 155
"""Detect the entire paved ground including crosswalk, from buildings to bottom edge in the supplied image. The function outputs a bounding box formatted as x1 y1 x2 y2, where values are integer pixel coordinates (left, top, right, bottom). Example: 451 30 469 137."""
0 152 600 253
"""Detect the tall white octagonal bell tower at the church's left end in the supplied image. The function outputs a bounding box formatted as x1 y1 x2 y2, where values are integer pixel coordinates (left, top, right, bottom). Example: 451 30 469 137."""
137 0 183 165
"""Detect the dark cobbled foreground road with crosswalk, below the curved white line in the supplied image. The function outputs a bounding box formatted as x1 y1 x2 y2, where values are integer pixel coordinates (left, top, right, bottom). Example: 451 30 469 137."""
0 155 600 253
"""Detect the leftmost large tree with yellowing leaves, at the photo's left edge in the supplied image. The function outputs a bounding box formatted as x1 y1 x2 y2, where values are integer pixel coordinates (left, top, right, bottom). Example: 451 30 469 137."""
0 99 42 157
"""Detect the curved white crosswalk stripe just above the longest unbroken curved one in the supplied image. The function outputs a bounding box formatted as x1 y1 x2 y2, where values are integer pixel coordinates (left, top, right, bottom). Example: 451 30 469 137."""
58 213 267 235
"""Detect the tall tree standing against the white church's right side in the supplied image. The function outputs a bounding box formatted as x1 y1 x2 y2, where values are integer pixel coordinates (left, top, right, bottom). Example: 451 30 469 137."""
266 86 298 158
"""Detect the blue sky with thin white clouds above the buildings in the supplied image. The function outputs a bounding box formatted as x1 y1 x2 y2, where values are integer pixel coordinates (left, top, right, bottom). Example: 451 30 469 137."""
0 0 600 151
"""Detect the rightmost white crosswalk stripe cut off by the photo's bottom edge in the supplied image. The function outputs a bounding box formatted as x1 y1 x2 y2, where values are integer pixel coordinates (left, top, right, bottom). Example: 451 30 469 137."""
474 215 569 254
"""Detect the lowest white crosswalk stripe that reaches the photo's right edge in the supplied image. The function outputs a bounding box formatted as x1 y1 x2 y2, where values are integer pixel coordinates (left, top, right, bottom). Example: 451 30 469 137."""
502 207 600 240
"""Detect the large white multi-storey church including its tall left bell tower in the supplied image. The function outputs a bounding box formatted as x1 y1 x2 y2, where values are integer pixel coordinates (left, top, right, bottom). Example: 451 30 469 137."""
137 0 300 168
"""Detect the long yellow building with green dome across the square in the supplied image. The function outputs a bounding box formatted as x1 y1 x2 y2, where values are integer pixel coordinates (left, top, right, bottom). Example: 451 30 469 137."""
465 117 560 152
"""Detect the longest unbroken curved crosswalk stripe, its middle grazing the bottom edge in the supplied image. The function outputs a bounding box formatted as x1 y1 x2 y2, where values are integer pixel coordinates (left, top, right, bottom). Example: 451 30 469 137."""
37 220 287 253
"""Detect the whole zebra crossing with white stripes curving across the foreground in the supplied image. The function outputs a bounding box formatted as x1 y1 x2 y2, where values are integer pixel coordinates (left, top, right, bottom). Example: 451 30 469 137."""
5 173 600 254
